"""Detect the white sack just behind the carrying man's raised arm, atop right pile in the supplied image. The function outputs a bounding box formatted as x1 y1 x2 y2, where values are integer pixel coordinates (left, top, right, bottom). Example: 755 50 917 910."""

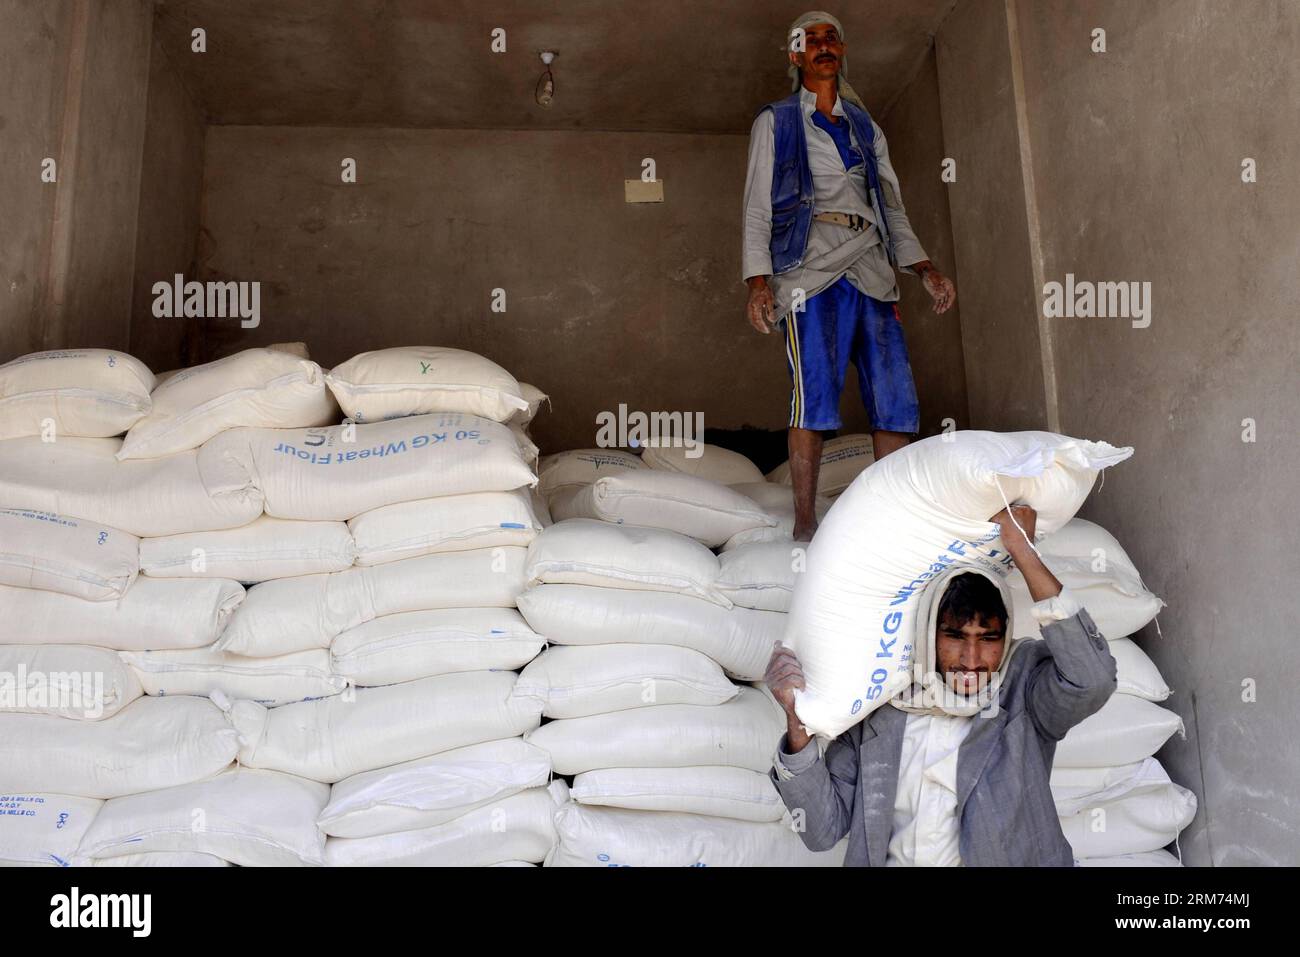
1008 519 1165 640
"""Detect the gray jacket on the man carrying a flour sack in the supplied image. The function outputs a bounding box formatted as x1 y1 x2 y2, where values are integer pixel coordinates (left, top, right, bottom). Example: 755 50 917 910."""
770 611 1115 867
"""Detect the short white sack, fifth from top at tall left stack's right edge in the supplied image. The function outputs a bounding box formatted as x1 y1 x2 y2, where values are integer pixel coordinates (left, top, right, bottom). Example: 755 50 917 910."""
330 609 546 687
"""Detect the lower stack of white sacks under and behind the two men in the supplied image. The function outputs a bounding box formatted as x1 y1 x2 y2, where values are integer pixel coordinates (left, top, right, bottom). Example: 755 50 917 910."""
525 436 1196 866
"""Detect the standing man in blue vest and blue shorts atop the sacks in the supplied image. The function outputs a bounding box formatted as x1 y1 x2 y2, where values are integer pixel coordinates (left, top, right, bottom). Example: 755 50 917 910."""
742 10 957 541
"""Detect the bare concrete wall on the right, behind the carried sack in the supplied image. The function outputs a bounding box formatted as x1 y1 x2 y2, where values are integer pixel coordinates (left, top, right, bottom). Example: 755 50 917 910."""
939 0 1300 865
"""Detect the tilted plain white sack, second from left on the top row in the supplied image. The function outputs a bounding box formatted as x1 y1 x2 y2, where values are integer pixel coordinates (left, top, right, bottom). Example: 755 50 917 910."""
117 348 338 459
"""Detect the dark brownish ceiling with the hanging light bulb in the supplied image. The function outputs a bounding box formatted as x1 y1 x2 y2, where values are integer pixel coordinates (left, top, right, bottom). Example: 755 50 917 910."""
156 0 956 133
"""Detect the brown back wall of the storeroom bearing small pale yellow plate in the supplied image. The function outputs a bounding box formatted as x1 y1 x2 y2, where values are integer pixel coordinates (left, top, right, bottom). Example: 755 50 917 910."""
192 121 959 450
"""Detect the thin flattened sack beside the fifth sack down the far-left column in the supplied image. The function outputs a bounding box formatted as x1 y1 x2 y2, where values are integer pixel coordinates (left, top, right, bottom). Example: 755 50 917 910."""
121 648 347 707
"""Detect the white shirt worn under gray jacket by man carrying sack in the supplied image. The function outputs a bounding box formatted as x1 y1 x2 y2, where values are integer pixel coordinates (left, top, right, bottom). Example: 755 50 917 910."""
776 589 1080 867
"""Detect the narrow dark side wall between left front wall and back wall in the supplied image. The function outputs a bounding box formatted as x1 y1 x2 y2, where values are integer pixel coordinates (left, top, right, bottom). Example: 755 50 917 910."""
130 26 207 372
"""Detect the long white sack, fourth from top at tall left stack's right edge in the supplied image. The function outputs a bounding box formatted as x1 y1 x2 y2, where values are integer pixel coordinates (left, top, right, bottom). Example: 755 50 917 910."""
215 545 528 658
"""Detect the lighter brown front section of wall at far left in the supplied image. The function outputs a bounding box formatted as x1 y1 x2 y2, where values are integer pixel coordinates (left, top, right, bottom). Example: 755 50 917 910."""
0 0 152 358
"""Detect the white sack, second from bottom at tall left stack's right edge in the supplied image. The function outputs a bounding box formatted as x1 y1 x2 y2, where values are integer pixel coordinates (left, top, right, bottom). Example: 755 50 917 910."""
317 737 551 837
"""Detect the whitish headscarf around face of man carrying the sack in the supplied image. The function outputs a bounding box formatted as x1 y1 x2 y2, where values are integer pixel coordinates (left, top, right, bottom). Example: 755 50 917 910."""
889 566 1022 718
